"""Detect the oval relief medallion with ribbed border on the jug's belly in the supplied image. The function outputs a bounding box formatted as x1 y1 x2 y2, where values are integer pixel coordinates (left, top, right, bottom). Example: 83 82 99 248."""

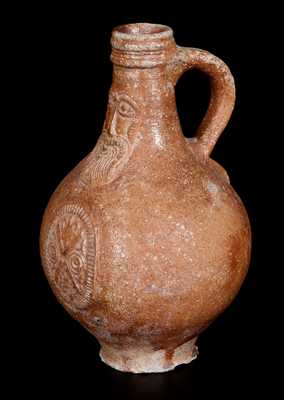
44 204 96 310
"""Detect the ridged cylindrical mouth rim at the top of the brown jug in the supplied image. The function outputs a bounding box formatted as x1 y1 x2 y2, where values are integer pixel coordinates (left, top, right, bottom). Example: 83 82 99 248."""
111 23 176 68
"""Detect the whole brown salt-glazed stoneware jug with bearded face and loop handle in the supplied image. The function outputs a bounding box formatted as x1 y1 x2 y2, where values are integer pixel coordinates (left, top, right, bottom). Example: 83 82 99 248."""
40 23 251 373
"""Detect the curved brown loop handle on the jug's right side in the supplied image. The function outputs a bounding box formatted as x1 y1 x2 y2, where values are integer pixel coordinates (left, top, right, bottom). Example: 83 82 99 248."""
169 46 235 161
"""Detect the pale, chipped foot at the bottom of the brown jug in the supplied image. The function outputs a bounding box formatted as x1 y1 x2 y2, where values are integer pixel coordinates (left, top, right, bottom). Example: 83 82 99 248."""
100 337 198 374
